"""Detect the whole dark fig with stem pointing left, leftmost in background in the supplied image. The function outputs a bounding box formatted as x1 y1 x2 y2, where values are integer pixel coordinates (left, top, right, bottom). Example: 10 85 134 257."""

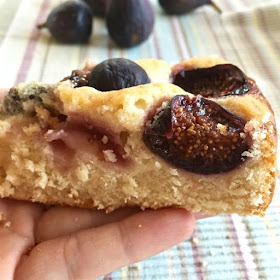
38 0 93 44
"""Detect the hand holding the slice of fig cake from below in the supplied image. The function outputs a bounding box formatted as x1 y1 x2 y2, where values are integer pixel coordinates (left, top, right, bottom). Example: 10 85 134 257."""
0 199 194 280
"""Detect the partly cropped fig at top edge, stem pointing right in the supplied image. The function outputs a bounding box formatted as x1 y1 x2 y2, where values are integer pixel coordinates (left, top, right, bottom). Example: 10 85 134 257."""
159 0 211 15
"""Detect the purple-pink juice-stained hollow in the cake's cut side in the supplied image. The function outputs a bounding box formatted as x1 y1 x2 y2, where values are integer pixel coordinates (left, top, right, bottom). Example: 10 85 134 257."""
45 119 131 168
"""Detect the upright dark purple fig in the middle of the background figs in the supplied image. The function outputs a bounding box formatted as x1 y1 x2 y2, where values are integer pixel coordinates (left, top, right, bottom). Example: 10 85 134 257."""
106 0 154 48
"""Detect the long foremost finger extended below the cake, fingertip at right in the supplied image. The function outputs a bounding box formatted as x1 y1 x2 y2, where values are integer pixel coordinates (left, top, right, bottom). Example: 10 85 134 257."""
15 209 194 280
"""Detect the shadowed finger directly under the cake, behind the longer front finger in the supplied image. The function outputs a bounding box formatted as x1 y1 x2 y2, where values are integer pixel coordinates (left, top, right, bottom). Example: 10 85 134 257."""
35 207 140 243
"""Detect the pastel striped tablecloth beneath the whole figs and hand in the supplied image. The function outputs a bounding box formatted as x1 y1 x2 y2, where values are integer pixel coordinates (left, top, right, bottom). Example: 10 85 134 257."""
0 0 280 280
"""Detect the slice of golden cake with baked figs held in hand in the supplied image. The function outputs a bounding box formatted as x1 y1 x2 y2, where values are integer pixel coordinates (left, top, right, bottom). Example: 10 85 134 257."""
0 57 276 216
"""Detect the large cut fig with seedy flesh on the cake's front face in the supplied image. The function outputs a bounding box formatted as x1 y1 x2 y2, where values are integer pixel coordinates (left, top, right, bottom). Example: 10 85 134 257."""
143 95 250 174
